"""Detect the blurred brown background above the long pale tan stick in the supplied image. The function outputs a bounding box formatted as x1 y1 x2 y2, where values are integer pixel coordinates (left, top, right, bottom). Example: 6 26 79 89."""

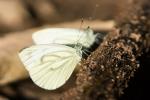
0 0 116 34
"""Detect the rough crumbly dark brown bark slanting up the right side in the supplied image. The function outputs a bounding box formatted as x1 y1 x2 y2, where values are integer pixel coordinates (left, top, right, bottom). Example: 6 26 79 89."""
61 0 150 100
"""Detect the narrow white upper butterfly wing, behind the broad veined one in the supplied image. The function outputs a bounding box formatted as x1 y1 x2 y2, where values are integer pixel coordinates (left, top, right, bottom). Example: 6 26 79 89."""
32 28 96 47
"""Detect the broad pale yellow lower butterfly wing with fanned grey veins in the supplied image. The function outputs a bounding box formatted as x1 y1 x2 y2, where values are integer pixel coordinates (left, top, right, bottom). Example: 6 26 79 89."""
19 44 81 90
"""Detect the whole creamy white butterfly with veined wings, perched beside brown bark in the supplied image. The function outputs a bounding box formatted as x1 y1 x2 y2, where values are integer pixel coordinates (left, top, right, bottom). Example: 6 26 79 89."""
19 28 95 90
